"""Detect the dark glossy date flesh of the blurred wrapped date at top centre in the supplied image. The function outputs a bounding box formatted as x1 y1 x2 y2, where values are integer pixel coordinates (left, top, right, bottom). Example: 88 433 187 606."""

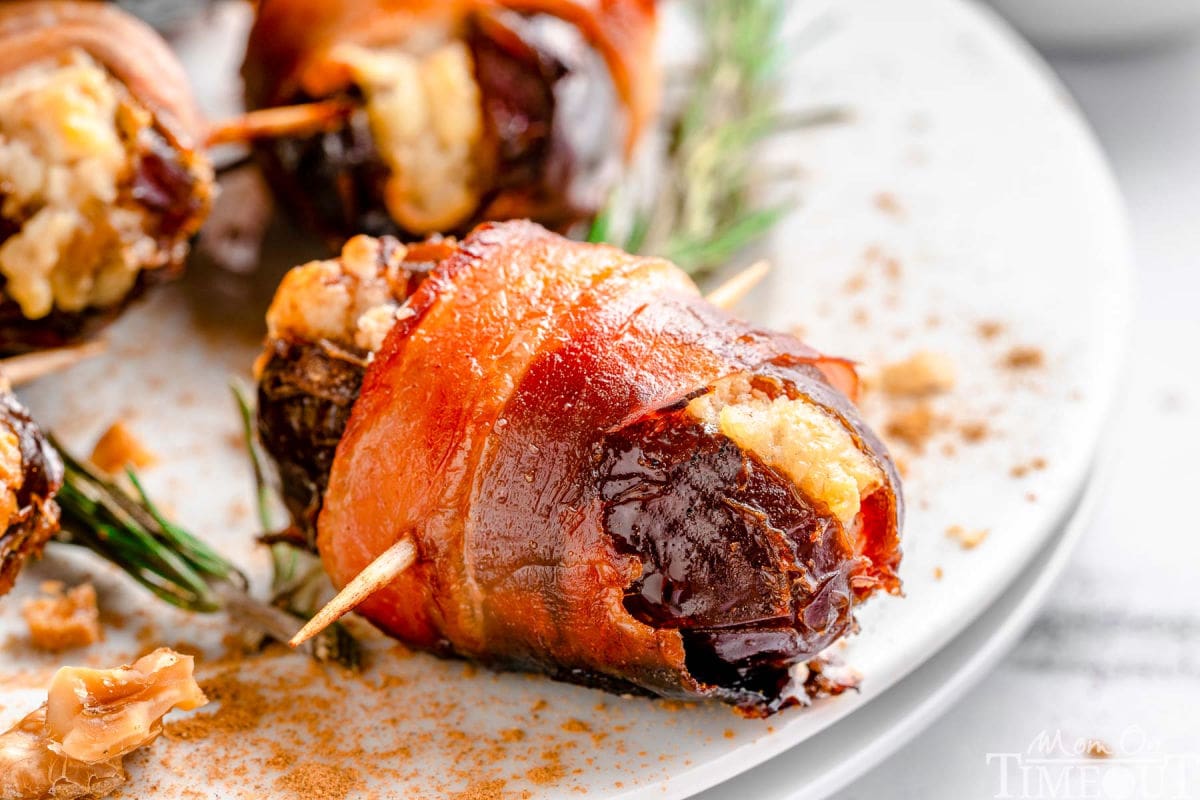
258 10 623 247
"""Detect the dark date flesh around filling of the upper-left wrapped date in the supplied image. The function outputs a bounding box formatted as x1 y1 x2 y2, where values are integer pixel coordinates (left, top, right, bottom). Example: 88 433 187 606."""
0 130 206 354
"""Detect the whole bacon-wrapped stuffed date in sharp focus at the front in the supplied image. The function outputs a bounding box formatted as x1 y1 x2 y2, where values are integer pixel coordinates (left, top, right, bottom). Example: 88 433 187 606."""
260 222 901 715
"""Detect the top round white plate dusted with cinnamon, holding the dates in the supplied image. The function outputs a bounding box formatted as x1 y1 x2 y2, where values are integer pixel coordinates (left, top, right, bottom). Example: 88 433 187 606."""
0 0 1129 799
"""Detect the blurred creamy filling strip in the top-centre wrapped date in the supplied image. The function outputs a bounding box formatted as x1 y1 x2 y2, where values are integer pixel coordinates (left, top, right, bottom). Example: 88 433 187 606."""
331 42 484 234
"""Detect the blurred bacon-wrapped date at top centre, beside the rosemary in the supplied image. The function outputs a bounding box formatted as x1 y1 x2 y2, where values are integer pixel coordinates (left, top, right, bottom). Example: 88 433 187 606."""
242 0 658 243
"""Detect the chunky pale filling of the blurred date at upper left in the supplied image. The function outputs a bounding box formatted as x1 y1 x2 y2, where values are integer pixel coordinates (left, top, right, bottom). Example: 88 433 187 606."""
0 52 164 319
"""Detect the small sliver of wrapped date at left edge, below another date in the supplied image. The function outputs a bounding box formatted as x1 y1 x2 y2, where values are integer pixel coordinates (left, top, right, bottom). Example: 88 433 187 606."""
0 386 62 595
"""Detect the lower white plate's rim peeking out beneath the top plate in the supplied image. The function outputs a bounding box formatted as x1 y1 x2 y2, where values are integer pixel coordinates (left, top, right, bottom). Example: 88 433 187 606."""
695 450 1109 800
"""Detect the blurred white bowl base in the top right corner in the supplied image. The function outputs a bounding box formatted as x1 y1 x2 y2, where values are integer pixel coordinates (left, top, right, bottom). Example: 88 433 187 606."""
991 0 1200 52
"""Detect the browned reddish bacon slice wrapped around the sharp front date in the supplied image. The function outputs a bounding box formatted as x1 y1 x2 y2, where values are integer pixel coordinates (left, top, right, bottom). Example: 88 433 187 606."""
318 223 902 714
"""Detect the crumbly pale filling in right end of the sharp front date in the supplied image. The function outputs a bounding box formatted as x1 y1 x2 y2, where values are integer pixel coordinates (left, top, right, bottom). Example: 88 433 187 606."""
688 377 883 528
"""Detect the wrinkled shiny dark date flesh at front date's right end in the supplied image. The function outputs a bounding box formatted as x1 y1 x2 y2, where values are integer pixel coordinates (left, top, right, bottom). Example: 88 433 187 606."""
596 403 853 710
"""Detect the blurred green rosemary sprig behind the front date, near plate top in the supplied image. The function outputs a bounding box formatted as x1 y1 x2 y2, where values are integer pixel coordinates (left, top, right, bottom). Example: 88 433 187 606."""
588 0 840 275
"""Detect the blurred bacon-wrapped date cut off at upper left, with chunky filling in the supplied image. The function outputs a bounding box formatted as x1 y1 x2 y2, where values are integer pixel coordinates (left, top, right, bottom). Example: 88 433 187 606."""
0 0 212 351
